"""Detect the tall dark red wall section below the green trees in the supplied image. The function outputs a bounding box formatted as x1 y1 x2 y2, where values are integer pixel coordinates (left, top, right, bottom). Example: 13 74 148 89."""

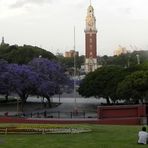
97 104 148 125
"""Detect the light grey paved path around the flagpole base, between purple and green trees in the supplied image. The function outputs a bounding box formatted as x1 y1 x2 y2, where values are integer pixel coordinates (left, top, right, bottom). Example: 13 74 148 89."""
28 98 105 118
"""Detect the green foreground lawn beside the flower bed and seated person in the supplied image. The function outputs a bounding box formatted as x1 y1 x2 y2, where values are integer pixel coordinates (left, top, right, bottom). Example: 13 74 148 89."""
0 125 148 148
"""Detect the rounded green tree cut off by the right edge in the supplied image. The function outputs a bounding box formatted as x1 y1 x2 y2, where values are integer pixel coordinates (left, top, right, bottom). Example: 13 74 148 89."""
117 71 148 103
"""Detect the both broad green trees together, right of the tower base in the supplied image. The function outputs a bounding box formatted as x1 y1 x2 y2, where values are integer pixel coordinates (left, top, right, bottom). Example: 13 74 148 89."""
78 62 148 104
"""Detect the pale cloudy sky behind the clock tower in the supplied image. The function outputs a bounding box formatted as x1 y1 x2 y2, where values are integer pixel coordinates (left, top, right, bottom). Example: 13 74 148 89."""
0 0 148 55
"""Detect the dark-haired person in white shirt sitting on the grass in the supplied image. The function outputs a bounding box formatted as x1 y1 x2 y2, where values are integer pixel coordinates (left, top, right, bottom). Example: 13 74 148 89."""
138 126 148 144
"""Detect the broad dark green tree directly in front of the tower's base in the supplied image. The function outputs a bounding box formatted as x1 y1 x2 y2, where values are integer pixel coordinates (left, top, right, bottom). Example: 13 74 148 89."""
78 66 127 104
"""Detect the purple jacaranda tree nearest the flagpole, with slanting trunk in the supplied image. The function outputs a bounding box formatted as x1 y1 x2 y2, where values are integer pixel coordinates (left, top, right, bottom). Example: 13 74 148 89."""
29 58 69 106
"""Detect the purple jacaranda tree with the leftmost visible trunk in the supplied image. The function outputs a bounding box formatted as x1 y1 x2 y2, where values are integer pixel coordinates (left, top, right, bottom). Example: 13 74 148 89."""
8 64 39 110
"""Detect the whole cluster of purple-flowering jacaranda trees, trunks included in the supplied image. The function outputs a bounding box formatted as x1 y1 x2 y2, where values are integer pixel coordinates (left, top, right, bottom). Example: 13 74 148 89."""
0 58 70 109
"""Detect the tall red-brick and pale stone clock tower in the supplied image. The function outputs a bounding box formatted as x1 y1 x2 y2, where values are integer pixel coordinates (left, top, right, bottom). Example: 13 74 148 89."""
84 2 97 73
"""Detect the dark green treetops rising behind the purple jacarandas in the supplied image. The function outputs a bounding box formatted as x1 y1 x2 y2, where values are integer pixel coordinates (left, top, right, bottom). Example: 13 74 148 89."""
0 44 56 64
